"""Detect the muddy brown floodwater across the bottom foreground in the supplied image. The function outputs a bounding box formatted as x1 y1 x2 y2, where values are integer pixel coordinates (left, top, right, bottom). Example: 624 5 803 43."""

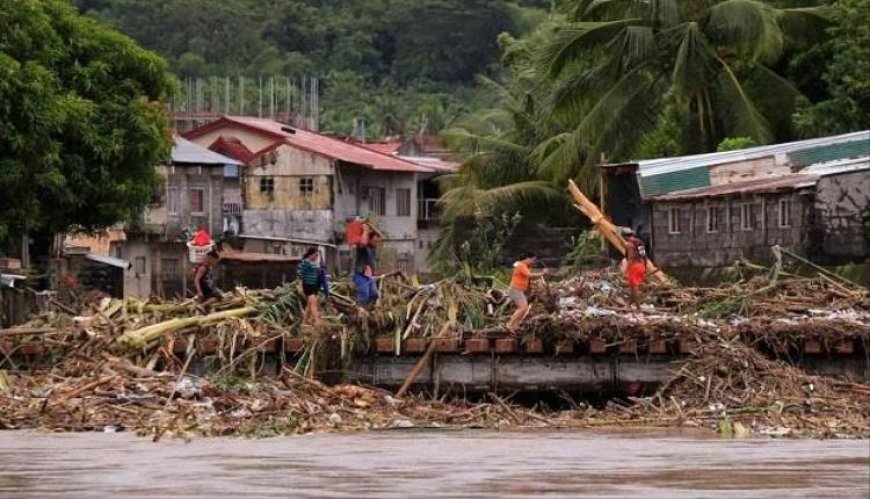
0 431 870 499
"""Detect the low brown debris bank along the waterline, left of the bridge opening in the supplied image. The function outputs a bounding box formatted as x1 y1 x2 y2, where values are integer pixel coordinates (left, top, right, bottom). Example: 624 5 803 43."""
0 350 548 440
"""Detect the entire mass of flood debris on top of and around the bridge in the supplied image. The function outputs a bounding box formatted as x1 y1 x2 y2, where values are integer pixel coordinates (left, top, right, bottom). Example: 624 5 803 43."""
0 270 870 438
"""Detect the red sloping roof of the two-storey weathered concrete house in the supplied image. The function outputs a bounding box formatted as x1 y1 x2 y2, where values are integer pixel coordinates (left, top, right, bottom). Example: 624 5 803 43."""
185 116 432 173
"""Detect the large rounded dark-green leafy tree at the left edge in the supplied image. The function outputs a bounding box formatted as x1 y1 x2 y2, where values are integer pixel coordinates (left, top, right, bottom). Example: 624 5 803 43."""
0 0 174 248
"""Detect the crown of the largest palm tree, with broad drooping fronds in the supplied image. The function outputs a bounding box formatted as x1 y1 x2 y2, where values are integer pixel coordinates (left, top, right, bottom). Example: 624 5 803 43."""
539 0 824 169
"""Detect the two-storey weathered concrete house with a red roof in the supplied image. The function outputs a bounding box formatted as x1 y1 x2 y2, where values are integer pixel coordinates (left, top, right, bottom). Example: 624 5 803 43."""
184 116 435 271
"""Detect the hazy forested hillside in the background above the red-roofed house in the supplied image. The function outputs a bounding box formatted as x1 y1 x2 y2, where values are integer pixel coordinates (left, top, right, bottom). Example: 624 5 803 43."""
74 0 549 136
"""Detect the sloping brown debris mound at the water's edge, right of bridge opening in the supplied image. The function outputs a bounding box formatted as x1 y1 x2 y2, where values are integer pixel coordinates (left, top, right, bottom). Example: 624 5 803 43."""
620 335 870 438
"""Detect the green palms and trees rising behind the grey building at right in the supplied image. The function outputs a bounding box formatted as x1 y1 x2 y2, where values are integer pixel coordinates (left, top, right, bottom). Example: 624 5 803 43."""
437 0 870 270
